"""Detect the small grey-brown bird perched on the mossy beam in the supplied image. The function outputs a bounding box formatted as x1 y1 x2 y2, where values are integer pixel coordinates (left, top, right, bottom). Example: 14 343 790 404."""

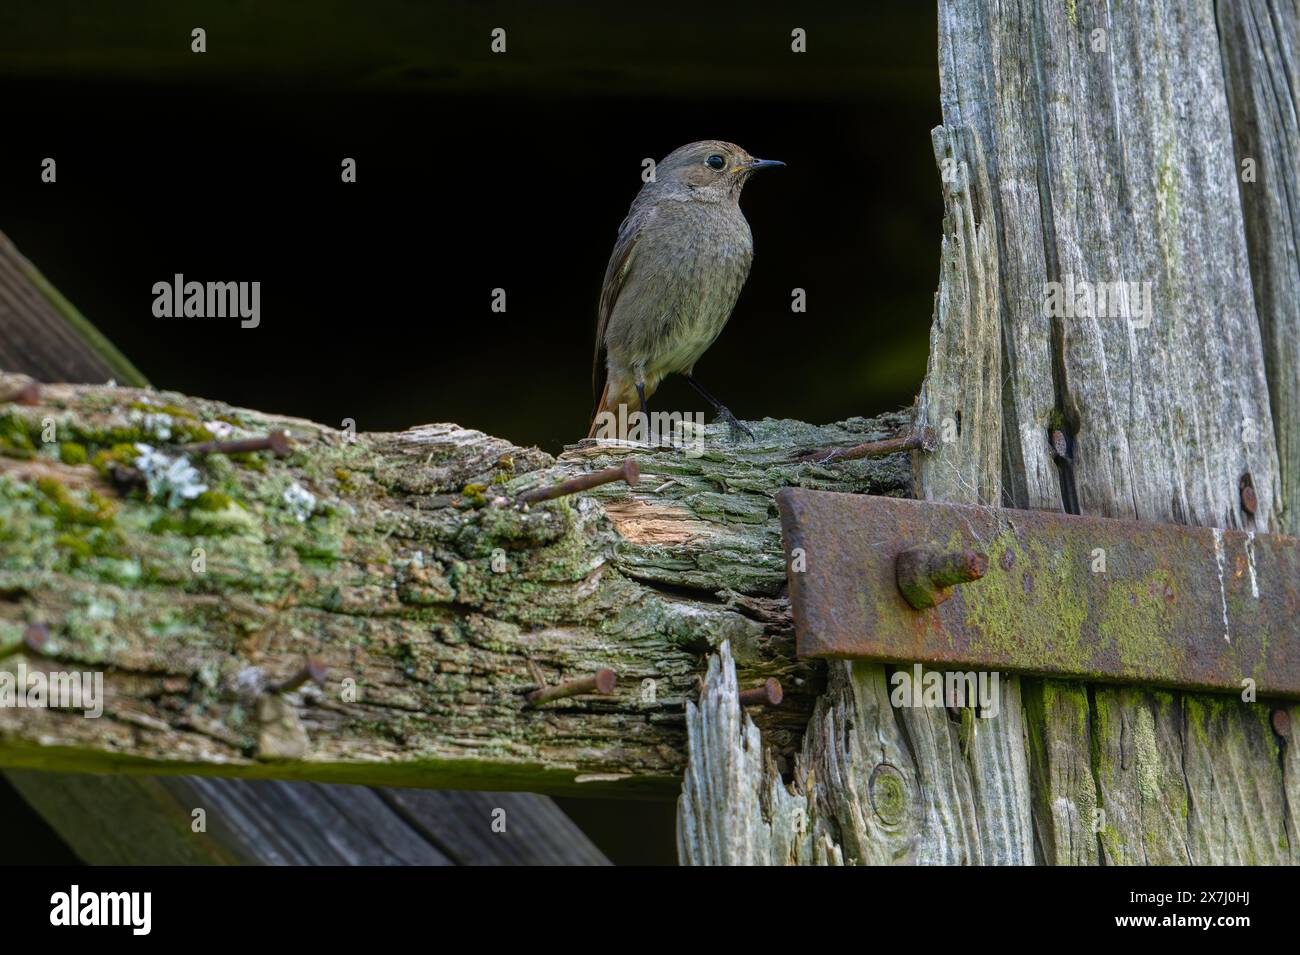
588 139 785 439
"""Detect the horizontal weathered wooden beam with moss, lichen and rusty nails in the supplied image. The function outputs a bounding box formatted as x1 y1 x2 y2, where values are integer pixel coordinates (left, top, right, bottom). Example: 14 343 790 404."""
0 377 910 795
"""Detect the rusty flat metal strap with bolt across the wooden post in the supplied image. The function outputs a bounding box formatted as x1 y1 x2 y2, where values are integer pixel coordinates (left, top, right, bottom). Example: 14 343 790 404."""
776 487 1300 698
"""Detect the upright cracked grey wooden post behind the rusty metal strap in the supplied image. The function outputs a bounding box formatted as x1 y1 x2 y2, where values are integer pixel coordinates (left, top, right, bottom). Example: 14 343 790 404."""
679 0 1300 864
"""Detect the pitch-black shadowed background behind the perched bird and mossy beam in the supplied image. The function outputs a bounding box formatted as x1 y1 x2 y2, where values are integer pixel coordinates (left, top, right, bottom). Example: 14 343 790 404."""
0 0 941 859
